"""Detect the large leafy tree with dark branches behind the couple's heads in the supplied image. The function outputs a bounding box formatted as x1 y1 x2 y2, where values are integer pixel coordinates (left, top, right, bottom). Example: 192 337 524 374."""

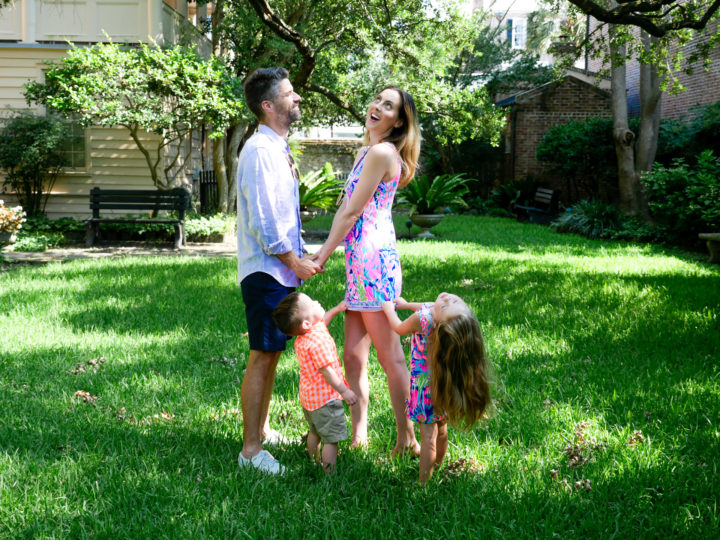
200 0 504 214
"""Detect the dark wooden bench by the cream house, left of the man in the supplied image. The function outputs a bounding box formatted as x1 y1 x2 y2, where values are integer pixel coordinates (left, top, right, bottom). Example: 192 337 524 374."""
85 187 190 249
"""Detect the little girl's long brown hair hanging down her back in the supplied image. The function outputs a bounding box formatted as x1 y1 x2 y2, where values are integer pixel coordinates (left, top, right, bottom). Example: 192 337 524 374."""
428 312 490 428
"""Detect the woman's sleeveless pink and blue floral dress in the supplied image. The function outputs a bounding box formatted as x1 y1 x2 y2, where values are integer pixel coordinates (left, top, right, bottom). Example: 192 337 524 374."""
345 143 402 311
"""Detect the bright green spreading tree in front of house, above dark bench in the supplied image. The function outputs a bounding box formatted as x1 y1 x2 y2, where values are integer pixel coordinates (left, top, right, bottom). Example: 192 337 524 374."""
25 43 242 189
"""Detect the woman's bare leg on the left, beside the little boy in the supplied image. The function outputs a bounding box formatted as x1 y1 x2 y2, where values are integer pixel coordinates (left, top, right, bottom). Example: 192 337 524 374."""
343 311 372 448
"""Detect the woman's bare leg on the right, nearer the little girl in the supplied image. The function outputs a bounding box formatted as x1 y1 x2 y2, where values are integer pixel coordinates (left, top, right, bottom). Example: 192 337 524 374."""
362 311 420 455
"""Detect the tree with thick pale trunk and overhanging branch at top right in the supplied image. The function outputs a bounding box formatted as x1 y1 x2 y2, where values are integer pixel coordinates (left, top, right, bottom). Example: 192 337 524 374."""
551 0 720 221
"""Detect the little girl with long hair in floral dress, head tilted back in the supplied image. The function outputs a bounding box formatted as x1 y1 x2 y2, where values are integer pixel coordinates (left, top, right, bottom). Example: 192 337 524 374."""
383 293 490 485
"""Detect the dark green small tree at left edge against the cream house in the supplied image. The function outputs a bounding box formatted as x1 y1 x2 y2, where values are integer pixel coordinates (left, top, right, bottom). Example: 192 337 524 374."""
0 114 67 216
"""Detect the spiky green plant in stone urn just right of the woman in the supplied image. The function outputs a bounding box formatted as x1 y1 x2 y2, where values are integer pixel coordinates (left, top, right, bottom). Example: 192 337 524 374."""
396 173 472 237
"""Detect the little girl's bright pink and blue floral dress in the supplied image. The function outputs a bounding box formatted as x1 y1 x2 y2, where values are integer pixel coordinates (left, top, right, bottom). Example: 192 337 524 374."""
405 304 443 424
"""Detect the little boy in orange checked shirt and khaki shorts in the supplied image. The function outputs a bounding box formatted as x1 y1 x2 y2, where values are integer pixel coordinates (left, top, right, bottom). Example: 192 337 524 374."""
273 292 358 473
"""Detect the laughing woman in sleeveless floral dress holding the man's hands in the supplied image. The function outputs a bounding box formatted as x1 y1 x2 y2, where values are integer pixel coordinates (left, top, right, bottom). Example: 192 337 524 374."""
314 86 420 455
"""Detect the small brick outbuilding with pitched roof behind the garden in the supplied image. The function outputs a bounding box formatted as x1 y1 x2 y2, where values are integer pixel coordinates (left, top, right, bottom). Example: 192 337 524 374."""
498 73 611 195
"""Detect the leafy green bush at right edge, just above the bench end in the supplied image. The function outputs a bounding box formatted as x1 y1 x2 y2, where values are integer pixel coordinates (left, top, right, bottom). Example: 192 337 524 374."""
642 150 720 243
